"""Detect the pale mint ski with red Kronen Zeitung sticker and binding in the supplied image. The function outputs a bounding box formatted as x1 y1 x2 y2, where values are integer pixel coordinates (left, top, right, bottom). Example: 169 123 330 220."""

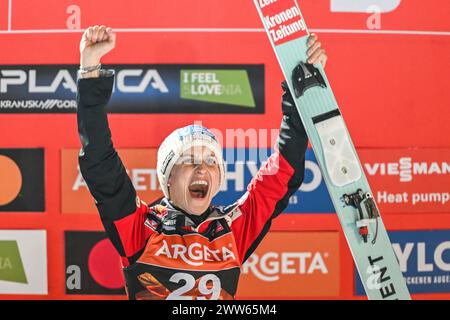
254 0 411 300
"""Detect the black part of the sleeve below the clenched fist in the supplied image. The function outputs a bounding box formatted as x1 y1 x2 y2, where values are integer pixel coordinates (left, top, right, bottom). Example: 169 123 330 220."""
77 75 137 256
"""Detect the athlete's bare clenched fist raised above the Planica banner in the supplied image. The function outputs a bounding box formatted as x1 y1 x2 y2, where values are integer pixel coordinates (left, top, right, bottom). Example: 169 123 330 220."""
80 26 116 68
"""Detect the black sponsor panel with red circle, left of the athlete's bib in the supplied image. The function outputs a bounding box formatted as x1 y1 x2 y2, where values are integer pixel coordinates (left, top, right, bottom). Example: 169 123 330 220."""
64 231 125 295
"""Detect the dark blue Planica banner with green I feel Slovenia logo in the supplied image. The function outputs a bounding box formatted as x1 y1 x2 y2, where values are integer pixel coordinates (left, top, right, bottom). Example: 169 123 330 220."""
0 65 265 113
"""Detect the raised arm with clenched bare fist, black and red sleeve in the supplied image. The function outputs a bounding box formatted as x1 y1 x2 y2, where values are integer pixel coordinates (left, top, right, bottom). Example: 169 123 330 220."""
77 26 148 265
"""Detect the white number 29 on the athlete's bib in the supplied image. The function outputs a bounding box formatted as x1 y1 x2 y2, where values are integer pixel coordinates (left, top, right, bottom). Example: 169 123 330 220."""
167 272 221 300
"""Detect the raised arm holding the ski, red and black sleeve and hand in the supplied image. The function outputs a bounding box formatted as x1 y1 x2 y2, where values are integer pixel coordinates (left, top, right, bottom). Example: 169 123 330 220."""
232 34 327 262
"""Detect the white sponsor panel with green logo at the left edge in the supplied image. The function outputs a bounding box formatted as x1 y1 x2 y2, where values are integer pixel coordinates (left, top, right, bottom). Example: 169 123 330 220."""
0 230 48 294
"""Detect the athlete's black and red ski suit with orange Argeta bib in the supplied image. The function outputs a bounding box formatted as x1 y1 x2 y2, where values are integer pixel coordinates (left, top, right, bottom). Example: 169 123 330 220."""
77 74 308 299
